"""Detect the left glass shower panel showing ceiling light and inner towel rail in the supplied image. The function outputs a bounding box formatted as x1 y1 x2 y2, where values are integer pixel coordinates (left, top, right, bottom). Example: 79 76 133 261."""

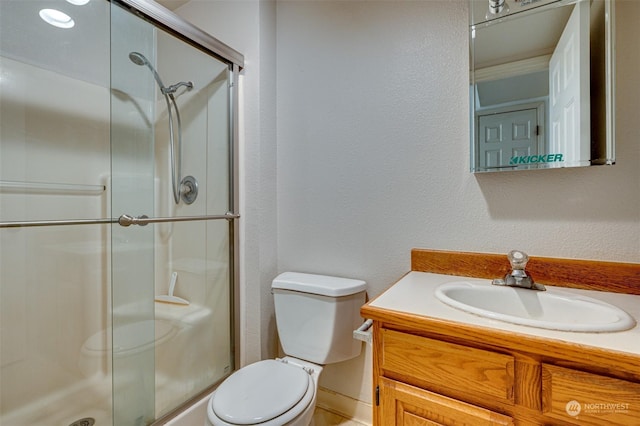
0 0 112 426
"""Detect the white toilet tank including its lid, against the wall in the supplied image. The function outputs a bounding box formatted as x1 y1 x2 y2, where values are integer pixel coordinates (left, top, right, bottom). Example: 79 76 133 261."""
271 272 366 364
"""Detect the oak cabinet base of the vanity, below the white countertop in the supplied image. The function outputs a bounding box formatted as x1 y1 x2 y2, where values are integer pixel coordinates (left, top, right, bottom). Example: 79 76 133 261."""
363 320 640 426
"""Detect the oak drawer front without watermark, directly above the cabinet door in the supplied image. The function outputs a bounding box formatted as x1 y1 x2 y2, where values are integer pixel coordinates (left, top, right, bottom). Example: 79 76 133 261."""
380 329 514 404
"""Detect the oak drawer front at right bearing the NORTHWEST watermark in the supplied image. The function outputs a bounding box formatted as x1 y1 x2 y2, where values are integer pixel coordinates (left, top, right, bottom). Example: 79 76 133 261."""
542 364 640 425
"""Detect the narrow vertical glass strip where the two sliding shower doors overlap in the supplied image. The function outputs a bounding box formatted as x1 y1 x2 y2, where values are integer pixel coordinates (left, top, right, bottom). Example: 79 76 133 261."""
110 3 156 425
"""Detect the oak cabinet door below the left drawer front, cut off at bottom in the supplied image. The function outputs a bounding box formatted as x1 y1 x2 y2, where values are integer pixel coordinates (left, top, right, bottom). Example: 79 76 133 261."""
378 377 513 426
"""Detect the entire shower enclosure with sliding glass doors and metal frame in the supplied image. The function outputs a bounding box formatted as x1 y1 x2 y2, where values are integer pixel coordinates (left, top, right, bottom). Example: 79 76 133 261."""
0 0 243 426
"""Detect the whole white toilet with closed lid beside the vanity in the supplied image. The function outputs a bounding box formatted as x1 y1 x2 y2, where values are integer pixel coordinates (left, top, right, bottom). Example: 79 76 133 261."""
205 272 366 426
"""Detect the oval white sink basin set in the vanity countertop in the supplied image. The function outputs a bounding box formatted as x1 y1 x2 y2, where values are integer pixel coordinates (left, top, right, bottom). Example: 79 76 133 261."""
435 281 636 333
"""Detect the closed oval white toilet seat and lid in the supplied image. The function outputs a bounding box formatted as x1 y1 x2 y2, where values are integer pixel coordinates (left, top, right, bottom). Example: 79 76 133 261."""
207 360 315 426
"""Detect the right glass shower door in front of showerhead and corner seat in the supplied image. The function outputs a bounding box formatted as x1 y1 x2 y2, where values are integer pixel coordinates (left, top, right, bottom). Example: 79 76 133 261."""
111 3 233 425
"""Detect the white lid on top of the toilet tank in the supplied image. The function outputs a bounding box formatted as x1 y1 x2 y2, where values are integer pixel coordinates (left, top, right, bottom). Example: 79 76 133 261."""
271 272 367 297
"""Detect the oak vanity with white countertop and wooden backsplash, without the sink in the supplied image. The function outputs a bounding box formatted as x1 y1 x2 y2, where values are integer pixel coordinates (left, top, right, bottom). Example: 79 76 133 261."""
361 249 640 426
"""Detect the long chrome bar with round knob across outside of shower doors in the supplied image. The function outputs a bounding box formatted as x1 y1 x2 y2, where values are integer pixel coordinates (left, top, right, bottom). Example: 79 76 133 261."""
0 213 240 229
